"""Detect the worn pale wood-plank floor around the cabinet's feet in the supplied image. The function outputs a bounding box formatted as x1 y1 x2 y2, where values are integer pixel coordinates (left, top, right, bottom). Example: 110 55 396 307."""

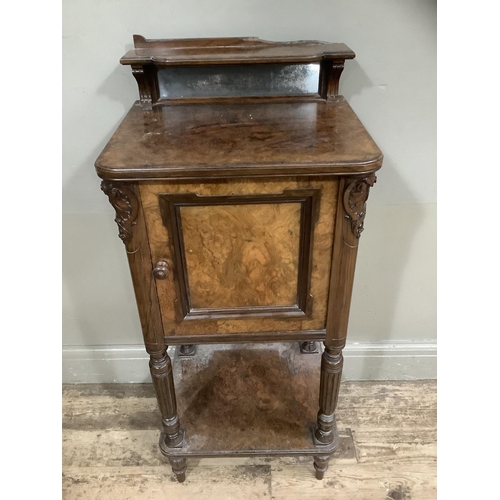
62 381 436 500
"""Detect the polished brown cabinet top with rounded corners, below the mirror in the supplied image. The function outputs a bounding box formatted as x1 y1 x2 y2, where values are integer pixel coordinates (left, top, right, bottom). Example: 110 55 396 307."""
95 96 382 180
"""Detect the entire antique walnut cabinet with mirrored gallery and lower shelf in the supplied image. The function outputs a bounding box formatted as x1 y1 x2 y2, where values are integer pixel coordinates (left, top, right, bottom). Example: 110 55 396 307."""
95 35 382 481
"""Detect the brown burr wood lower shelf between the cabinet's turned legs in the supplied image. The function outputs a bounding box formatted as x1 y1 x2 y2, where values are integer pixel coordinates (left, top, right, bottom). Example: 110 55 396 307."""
160 342 338 457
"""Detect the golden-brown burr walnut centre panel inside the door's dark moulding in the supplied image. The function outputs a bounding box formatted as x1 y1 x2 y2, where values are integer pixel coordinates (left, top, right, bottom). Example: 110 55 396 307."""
181 203 301 308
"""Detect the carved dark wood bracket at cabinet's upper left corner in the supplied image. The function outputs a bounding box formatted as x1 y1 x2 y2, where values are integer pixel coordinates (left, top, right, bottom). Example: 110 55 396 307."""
101 181 139 250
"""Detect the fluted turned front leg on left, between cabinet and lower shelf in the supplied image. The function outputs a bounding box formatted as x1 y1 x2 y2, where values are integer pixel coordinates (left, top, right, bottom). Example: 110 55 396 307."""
149 350 184 448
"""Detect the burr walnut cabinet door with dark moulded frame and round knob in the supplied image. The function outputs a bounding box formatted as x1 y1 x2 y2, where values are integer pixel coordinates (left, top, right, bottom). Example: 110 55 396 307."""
141 178 338 336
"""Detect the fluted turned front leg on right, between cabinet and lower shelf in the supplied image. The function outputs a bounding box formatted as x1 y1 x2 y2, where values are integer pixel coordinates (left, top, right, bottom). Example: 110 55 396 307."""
314 346 343 444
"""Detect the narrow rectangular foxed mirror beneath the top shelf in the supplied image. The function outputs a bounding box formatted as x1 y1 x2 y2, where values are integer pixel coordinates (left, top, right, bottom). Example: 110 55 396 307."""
158 63 319 99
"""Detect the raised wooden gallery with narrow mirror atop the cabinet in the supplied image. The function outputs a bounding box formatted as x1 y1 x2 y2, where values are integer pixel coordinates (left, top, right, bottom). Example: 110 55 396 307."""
120 35 355 111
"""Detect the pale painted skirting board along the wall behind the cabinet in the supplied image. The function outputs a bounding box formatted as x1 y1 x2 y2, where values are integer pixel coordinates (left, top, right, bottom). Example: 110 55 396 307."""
62 340 437 384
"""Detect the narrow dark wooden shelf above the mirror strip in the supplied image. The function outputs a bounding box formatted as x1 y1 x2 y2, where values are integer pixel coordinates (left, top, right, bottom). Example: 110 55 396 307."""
120 35 355 66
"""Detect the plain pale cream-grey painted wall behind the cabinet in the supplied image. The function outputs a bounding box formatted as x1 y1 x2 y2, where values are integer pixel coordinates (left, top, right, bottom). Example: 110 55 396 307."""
63 0 436 352
